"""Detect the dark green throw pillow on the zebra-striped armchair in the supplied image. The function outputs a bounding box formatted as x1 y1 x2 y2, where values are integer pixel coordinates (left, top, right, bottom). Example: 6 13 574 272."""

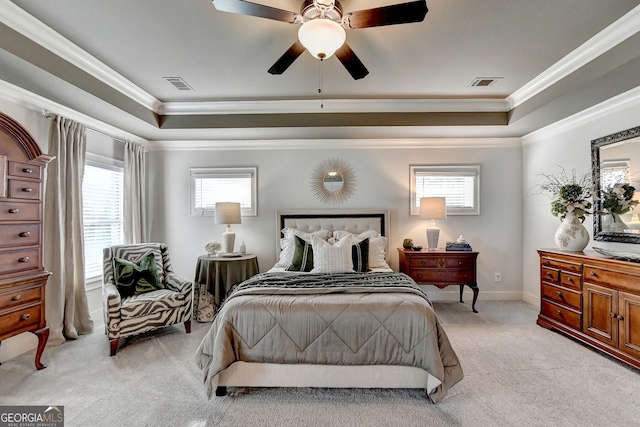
113 252 164 298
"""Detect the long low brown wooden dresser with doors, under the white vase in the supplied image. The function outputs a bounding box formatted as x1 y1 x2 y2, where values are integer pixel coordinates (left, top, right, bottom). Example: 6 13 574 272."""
537 250 640 368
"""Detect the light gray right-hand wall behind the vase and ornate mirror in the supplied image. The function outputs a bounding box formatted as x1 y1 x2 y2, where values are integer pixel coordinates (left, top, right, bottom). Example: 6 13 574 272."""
523 102 640 306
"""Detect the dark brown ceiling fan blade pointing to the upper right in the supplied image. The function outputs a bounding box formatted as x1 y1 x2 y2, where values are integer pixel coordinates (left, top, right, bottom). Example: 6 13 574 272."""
346 0 429 30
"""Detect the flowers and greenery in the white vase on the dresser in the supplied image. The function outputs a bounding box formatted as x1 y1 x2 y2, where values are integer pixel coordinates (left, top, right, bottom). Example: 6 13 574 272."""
538 169 594 221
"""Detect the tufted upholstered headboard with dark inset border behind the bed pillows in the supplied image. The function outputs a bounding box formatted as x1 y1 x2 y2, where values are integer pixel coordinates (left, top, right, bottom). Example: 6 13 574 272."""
276 209 391 257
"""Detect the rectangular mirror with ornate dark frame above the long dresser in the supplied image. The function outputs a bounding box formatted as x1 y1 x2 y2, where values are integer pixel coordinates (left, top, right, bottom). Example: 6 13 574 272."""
591 126 640 244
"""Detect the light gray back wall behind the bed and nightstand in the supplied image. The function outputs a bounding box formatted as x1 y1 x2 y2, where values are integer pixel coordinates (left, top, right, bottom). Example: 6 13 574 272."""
148 141 522 300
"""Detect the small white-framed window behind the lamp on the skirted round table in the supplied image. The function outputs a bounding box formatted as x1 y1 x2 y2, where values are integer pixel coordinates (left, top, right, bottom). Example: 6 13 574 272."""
191 167 258 216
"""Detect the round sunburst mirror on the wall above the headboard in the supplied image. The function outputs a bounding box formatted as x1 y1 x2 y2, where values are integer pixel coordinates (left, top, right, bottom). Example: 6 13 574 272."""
311 159 356 204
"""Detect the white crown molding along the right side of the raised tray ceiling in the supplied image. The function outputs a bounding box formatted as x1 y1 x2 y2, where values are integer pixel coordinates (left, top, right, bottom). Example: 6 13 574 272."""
506 6 640 108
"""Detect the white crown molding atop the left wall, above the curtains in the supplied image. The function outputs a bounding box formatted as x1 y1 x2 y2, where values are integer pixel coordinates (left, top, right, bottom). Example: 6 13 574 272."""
0 80 149 147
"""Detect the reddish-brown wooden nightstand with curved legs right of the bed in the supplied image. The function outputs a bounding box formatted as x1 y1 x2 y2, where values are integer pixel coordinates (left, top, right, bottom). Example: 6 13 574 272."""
398 248 479 313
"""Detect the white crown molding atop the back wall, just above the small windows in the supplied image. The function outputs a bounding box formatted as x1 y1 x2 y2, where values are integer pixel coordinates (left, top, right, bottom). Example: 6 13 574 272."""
146 138 522 151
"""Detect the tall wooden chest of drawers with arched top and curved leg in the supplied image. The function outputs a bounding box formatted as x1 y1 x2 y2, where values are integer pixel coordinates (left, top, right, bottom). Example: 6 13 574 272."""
0 113 52 369
